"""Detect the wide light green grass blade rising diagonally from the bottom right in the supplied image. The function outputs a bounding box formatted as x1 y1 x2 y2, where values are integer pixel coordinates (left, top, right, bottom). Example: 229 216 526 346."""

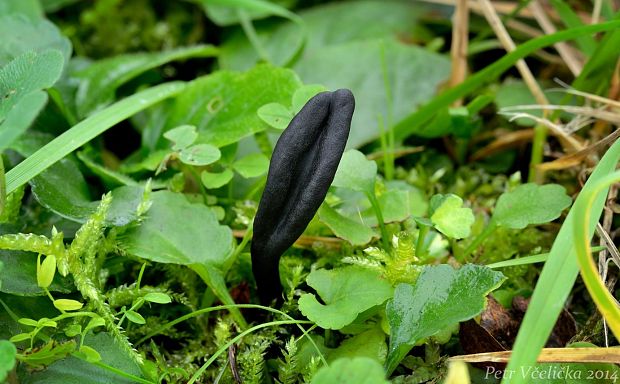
502 141 620 383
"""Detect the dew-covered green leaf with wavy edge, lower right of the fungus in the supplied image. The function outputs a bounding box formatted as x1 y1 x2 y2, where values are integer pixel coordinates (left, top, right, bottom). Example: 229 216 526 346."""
386 264 505 374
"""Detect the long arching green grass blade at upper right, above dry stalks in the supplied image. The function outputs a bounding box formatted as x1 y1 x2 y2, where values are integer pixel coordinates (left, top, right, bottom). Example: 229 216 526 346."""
392 20 620 140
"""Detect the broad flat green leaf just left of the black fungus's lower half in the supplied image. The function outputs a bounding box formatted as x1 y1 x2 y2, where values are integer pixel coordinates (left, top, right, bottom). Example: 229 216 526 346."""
119 191 233 268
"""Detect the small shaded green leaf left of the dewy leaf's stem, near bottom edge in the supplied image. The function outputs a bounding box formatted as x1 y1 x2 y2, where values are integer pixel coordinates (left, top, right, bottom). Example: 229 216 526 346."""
327 327 387 364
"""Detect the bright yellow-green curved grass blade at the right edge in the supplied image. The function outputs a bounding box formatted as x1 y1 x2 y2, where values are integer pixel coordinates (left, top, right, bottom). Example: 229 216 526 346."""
573 172 620 340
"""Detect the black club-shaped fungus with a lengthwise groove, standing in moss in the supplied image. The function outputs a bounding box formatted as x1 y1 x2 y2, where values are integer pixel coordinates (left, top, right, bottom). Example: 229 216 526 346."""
251 89 355 304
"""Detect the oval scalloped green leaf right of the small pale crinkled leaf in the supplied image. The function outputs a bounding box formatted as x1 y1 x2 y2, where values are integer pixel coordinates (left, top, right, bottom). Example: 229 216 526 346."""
493 183 572 229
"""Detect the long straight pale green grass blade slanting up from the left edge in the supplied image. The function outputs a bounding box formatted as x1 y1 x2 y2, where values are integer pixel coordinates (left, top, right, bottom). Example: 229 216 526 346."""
6 82 185 193
